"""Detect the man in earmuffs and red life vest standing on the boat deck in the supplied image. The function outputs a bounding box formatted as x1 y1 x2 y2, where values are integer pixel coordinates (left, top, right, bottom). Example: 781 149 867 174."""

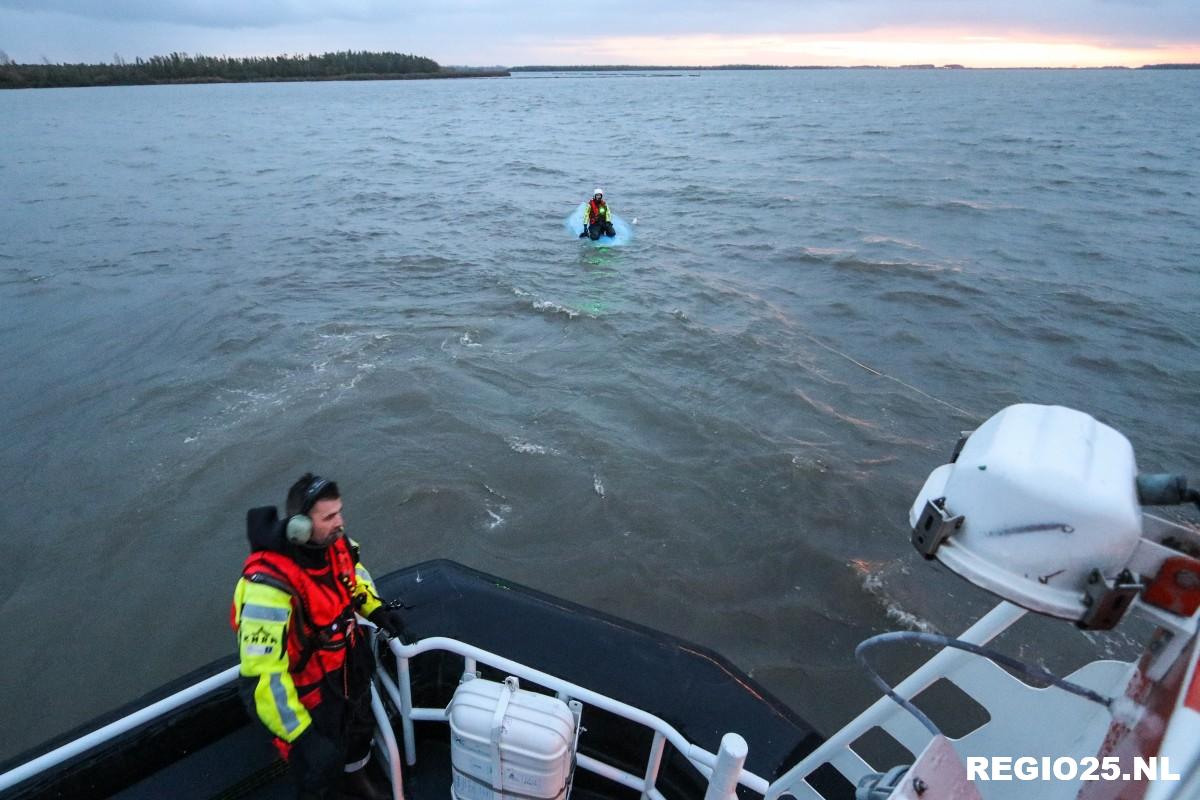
232 473 403 800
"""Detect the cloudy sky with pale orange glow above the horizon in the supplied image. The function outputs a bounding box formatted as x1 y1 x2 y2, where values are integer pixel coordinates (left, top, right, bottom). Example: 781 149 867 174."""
0 0 1200 66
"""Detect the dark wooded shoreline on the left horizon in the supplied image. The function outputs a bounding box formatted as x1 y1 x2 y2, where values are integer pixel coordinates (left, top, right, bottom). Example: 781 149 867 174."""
0 50 443 89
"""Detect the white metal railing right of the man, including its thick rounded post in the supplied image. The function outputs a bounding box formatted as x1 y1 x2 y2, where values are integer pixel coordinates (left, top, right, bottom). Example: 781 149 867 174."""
377 637 769 800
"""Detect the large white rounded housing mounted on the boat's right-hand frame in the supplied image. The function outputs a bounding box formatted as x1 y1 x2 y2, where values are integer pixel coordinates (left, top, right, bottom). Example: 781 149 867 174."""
910 404 1141 619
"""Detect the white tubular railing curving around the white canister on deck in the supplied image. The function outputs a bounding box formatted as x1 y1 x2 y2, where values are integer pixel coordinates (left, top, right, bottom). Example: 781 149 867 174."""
384 636 770 798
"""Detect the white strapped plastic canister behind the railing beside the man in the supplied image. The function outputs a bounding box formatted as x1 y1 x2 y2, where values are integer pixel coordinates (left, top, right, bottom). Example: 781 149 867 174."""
449 678 575 800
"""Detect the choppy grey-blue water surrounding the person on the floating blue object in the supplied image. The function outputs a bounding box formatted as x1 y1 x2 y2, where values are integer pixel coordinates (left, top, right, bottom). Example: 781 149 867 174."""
0 71 1200 756
